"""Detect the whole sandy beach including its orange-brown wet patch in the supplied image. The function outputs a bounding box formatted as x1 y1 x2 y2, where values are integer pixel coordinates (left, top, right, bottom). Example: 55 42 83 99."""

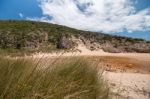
28 45 150 99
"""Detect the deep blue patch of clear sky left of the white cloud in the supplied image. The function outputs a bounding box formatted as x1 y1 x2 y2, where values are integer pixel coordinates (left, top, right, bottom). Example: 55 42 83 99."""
0 0 42 19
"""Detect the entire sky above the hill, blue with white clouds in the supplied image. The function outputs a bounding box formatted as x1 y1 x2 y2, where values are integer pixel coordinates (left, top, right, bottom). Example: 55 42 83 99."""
0 0 150 40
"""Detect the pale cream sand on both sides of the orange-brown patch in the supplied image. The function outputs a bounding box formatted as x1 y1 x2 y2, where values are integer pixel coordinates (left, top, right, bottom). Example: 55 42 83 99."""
22 44 150 99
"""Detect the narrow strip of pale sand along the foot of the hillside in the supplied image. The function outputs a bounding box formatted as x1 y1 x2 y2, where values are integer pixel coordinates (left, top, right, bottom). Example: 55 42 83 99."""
32 45 150 58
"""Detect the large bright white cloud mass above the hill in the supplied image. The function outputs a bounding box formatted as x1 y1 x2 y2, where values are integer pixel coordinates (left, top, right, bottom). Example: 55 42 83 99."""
30 0 150 33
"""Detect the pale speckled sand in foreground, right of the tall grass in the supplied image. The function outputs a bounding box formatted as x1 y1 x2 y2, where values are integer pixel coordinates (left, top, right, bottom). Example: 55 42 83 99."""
103 72 150 99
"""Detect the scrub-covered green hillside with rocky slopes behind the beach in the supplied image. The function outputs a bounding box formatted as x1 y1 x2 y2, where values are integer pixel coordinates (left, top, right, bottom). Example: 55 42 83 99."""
0 20 150 53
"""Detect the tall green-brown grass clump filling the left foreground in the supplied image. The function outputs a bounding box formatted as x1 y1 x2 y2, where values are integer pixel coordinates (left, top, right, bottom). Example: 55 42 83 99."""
0 57 109 99
